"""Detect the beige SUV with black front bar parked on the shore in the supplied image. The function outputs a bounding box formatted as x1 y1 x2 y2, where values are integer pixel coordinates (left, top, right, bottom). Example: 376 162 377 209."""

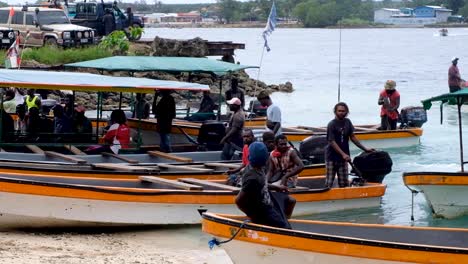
0 6 97 47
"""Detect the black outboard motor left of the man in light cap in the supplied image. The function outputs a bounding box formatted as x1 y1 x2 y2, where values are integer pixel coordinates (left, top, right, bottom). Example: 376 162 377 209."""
197 121 226 151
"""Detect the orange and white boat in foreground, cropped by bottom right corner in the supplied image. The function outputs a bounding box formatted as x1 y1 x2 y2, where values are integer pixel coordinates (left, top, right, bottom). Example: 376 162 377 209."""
202 211 468 264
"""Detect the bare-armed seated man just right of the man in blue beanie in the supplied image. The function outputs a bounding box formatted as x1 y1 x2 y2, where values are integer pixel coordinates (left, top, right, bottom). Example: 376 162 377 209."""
267 135 304 188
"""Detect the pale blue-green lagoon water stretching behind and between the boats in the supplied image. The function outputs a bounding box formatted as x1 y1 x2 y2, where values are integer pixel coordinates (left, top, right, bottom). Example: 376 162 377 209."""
144 28 468 227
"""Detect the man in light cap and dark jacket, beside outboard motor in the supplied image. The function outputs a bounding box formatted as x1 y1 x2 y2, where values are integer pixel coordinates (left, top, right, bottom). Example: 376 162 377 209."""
220 97 245 160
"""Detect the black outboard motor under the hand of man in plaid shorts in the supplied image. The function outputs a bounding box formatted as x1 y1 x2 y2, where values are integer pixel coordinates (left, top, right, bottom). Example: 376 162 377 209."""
353 151 393 183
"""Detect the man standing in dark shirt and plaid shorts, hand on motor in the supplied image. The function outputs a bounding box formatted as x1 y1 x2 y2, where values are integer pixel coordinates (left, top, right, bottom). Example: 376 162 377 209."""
325 102 374 188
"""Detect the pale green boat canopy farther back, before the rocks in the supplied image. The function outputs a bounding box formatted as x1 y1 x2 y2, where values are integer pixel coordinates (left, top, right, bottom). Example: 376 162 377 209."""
65 56 258 76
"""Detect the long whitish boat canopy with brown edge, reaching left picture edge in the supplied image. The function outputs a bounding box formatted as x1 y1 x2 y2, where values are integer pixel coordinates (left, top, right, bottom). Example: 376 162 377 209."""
0 69 209 93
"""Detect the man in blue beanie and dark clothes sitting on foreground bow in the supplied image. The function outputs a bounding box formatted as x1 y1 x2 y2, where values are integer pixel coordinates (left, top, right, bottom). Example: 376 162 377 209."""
236 142 291 228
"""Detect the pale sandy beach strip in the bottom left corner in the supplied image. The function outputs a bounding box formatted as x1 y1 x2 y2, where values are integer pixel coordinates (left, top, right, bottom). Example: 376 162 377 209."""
0 226 232 264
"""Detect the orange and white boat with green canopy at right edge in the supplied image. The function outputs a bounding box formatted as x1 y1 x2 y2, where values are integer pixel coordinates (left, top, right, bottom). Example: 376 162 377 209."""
403 89 468 218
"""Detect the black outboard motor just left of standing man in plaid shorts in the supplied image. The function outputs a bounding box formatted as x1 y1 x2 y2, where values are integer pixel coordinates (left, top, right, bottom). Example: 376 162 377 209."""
299 135 328 164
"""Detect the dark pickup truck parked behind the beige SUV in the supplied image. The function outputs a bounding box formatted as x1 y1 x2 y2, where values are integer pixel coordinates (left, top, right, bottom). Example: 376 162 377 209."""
71 2 144 37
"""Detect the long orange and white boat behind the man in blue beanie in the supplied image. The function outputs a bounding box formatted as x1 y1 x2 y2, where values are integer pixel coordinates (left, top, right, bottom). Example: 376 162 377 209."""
0 174 386 228
